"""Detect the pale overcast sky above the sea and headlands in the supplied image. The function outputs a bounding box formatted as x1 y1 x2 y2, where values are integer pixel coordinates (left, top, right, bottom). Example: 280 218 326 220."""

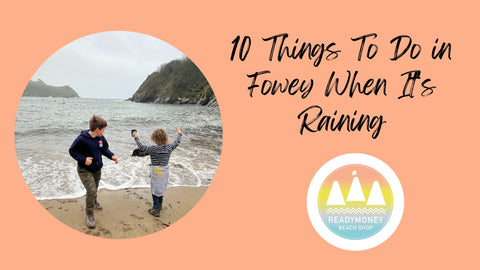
32 31 185 99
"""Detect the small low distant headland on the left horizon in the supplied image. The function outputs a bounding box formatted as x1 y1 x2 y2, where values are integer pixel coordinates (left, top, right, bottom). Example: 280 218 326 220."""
23 79 79 98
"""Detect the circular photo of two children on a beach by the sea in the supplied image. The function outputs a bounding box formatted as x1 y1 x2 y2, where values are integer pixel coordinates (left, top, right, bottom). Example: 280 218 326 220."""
15 31 223 239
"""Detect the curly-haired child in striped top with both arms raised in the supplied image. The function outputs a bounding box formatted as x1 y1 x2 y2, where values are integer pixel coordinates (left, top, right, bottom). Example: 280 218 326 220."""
132 128 182 217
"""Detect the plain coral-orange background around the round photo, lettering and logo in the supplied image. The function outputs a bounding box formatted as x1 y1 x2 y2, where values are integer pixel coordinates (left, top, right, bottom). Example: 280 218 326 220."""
0 0 480 269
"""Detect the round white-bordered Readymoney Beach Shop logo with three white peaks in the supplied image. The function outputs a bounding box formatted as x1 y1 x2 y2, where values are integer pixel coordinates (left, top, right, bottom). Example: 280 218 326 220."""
307 154 404 250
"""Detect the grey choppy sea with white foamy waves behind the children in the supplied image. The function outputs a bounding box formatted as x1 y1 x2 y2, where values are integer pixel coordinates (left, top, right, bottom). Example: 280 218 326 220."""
15 97 223 200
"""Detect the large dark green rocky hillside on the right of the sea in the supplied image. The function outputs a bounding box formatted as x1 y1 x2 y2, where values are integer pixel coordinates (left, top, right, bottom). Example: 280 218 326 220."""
129 58 216 105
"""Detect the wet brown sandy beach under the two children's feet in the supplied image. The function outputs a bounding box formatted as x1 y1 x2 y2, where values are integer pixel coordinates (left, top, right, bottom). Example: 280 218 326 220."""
40 187 208 239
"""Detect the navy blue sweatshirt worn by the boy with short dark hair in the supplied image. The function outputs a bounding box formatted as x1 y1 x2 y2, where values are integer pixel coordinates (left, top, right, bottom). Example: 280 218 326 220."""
68 130 114 172
